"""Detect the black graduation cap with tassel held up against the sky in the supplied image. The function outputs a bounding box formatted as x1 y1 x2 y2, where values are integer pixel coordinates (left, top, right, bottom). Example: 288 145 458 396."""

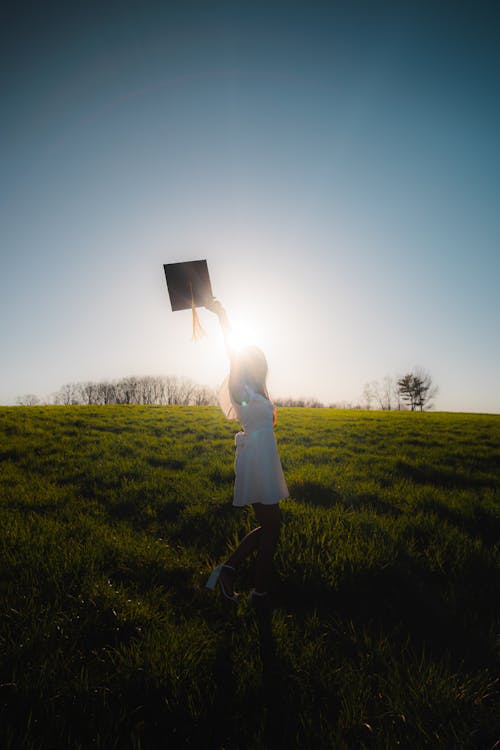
163 260 213 341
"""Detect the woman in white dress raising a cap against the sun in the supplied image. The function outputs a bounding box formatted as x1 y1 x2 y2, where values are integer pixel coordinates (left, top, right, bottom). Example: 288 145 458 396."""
206 298 289 605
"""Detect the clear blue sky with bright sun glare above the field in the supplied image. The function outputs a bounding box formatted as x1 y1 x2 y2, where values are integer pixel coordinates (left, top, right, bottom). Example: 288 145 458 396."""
0 0 500 413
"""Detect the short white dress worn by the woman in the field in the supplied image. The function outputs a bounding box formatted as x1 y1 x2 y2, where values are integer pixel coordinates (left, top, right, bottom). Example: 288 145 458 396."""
219 378 289 507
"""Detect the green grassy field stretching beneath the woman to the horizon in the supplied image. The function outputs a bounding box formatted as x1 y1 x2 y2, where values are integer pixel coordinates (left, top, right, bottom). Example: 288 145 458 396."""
0 406 500 750
